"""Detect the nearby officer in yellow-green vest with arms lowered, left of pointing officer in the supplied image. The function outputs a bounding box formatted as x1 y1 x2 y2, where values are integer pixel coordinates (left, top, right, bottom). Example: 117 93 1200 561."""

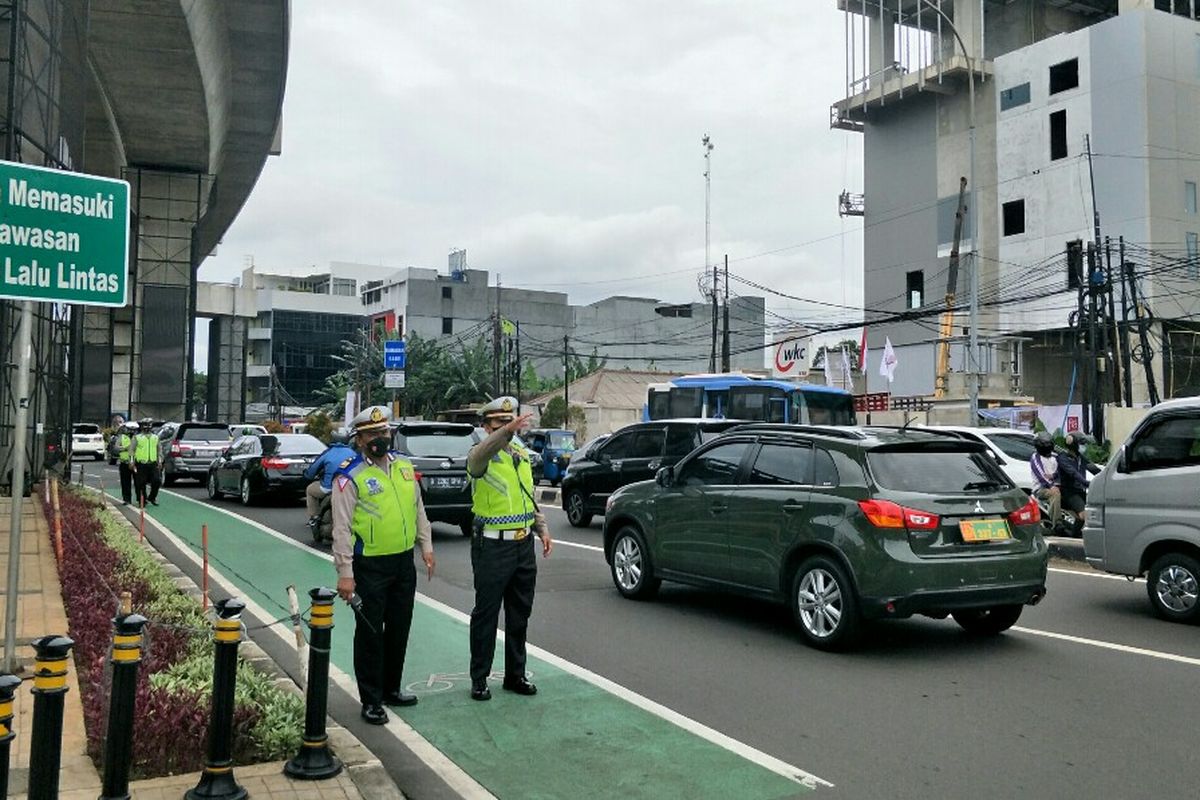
332 405 433 724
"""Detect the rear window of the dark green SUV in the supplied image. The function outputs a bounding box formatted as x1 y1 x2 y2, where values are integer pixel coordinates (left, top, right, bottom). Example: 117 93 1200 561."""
866 445 1013 494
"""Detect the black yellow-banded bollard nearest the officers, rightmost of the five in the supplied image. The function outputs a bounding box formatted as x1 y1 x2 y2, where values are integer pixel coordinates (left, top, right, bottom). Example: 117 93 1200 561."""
283 587 342 781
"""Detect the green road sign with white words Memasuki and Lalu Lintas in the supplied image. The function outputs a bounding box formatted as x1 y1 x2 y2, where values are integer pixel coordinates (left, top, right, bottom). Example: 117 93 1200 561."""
0 161 130 306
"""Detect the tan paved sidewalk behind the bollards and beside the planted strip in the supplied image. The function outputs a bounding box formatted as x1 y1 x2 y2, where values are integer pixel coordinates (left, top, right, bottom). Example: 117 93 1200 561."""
0 495 393 800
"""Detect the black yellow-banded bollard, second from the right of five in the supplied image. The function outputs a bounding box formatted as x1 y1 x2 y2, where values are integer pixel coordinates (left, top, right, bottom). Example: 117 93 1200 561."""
184 597 247 800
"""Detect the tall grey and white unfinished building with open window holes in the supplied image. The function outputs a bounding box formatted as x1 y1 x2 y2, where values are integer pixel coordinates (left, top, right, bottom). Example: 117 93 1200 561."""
832 0 1200 431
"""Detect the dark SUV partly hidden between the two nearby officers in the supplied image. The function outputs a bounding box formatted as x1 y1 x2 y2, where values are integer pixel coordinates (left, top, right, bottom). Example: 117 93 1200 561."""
392 422 479 536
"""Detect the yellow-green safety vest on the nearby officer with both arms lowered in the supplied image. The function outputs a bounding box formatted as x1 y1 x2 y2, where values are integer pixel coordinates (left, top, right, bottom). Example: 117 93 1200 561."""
337 455 420 555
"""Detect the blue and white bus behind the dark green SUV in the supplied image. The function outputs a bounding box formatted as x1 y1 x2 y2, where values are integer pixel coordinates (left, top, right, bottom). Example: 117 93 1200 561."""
642 373 856 425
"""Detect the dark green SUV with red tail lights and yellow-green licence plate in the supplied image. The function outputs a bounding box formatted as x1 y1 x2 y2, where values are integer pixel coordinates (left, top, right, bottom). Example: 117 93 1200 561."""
604 425 1048 650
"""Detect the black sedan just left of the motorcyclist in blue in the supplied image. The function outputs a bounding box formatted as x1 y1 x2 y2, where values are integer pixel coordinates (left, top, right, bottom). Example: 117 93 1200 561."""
208 433 325 506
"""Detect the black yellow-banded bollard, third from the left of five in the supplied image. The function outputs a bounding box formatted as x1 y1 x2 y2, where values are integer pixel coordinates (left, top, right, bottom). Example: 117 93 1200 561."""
100 614 146 800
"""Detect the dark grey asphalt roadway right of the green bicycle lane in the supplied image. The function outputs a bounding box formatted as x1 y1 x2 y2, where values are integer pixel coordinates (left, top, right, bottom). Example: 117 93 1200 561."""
88 465 1200 800
